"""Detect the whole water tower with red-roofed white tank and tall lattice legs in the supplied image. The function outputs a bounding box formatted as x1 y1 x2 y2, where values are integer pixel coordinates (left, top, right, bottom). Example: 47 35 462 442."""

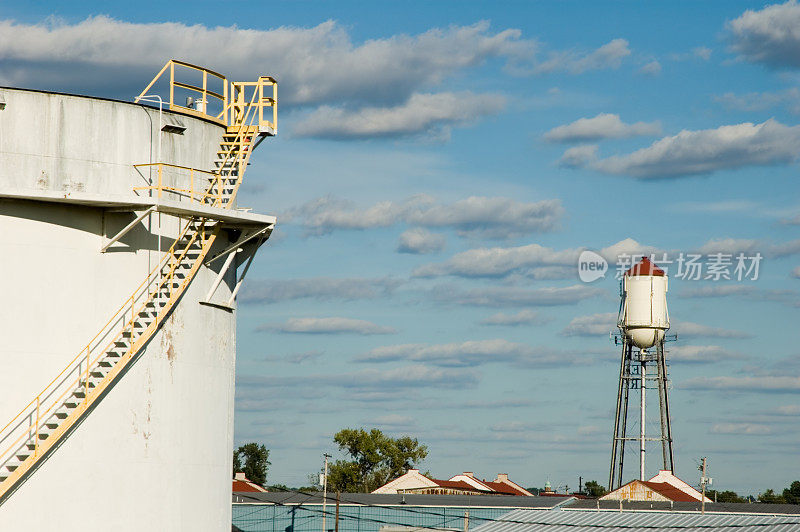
608 257 673 490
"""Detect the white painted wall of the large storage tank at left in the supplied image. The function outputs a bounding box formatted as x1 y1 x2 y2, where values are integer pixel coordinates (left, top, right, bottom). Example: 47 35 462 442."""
0 89 260 532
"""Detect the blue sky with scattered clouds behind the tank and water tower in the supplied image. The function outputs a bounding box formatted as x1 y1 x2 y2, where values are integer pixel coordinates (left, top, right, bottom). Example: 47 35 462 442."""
0 2 800 493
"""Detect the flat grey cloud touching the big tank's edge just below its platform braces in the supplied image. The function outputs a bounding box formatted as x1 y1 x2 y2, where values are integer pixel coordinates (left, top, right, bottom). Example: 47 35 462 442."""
239 277 401 303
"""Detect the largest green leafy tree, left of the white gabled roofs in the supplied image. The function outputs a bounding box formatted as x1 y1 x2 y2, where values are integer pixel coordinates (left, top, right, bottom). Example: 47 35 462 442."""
328 429 428 493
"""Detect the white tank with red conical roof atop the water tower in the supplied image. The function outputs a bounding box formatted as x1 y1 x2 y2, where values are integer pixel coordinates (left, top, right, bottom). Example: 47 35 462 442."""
617 257 669 349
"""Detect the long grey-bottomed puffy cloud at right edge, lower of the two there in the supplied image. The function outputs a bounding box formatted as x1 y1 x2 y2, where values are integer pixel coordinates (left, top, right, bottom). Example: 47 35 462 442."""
561 119 800 179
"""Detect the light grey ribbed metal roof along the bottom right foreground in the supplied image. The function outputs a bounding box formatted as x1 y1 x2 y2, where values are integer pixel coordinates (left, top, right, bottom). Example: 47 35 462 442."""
472 509 800 532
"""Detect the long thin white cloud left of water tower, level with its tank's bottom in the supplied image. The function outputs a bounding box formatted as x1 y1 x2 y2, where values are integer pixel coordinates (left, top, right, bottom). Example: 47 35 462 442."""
355 339 580 367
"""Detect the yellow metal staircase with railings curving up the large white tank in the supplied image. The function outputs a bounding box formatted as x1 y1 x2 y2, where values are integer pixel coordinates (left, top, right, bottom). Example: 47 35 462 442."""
0 61 277 502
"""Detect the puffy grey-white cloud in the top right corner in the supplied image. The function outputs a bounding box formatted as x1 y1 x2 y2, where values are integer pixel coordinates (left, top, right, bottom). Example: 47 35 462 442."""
728 0 800 67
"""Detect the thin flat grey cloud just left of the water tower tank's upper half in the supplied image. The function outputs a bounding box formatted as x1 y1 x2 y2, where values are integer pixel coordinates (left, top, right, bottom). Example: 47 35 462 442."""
431 284 604 307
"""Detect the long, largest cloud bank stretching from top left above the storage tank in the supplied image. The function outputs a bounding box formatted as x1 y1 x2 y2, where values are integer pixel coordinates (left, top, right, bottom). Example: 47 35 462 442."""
0 16 536 104
